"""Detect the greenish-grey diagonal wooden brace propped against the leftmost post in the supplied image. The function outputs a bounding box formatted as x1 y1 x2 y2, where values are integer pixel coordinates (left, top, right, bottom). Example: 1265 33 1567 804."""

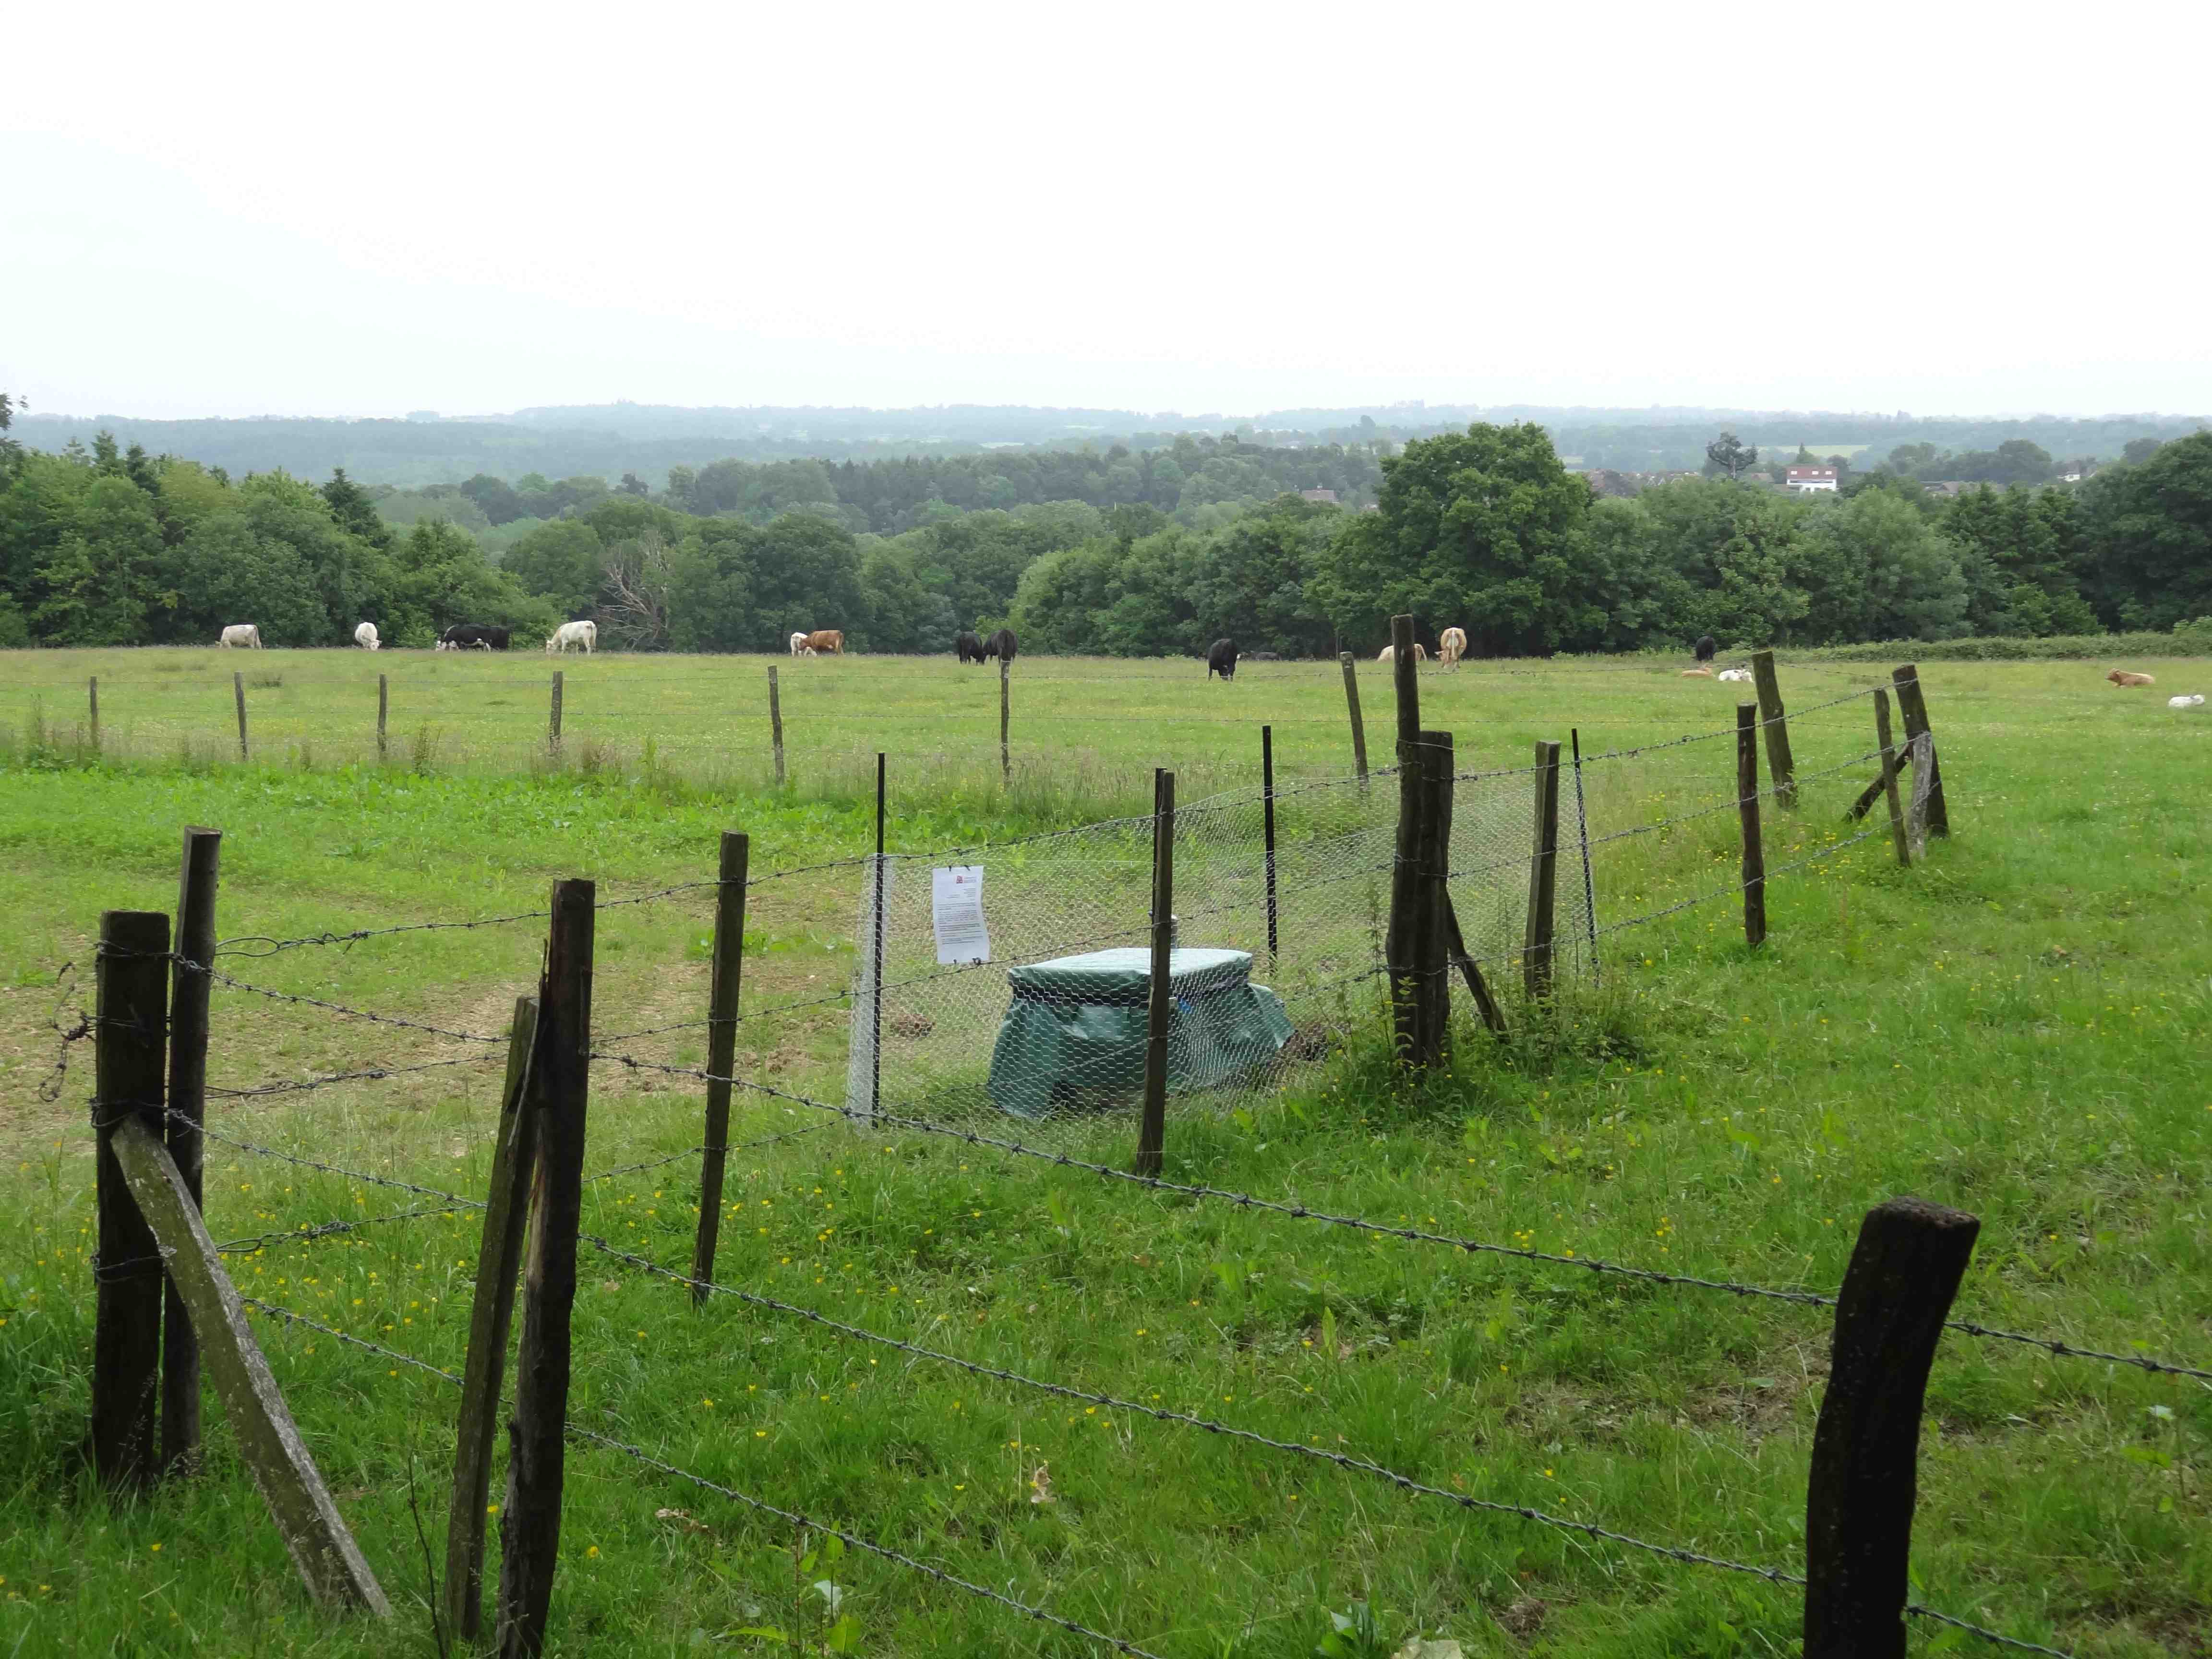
108 1117 392 1617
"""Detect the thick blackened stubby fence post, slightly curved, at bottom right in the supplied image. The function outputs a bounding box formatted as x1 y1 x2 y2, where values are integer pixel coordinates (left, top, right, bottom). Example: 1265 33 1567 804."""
1805 1199 1982 1659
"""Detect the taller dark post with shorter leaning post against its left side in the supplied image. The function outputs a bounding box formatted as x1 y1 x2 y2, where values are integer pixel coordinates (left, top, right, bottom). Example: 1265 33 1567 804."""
498 880 597 1659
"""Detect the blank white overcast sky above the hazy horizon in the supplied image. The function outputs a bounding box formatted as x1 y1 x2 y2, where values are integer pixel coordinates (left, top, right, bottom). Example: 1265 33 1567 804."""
0 0 2212 429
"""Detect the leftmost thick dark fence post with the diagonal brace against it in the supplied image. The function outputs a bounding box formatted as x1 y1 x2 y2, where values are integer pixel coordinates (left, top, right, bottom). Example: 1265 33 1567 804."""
93 909 168 1487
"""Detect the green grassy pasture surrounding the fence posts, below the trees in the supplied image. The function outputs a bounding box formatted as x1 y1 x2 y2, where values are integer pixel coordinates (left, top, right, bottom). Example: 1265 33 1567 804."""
0 652 2212 1659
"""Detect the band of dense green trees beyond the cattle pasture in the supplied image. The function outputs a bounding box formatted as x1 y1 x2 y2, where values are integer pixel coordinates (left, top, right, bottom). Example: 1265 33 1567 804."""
0 400 2212 657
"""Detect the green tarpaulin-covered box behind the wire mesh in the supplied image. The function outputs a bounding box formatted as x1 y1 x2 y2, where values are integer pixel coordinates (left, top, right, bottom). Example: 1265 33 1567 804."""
991 947 1289 1117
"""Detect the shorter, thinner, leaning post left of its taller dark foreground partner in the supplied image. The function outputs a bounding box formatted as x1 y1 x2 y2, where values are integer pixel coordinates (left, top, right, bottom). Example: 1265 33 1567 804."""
443 998 538 1641
